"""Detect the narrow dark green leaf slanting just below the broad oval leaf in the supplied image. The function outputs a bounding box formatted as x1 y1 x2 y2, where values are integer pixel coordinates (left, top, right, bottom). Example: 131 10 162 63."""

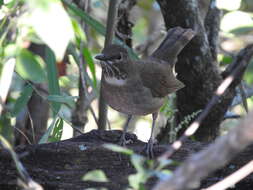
12 85 33 116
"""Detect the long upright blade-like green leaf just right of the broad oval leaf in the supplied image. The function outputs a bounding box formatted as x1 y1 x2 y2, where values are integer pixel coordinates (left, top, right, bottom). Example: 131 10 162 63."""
45 47 61 116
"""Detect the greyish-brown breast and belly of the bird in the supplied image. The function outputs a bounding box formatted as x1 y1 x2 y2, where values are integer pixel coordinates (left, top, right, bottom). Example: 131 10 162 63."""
101 78 164 115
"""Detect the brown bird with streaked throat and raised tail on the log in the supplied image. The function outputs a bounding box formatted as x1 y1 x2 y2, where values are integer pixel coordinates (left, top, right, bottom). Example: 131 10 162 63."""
95 27 194 157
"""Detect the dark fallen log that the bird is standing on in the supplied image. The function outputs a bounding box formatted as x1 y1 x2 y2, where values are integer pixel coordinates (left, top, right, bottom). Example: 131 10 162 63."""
0 130 253 190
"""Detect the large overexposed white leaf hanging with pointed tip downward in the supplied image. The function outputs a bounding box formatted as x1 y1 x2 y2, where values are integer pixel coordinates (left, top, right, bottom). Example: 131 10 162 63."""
28 0 74 61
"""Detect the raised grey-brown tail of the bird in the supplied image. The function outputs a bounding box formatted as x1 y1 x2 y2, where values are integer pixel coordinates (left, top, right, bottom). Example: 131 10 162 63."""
151 27 195 64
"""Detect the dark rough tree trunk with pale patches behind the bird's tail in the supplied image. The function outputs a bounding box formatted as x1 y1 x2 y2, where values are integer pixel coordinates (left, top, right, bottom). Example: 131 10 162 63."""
157 0 235 141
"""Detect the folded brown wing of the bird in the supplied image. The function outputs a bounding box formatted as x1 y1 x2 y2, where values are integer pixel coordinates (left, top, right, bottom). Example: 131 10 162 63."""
140 61 184 97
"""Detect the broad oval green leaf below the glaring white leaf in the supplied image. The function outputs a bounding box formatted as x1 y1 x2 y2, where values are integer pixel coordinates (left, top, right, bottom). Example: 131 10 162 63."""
16 49 46 83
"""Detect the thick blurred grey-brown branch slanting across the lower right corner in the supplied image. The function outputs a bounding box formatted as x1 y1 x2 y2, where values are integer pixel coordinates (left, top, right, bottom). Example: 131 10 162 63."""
153 111 253 190
